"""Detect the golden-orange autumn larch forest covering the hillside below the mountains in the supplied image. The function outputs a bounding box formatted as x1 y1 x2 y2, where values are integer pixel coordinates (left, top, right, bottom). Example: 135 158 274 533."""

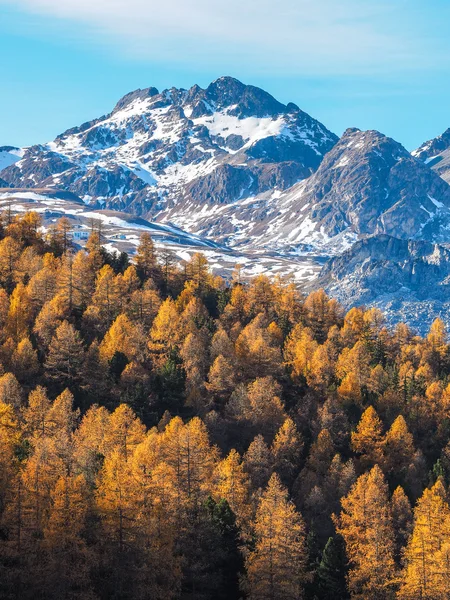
0 212 450 600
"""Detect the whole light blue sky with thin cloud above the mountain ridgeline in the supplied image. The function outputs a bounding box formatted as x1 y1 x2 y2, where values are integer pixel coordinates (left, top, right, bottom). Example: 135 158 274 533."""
0 0 450 150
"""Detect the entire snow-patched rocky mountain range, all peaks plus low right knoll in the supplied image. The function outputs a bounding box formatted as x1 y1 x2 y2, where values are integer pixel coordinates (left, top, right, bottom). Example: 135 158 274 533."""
0 77 450 327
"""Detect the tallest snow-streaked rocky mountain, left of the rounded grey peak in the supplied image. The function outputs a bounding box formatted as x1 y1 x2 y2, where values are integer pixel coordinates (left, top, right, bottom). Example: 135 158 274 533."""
0 77 338 225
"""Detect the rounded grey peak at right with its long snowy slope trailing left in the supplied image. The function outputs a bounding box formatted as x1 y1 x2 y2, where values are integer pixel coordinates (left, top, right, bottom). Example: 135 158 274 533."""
131 129 450 254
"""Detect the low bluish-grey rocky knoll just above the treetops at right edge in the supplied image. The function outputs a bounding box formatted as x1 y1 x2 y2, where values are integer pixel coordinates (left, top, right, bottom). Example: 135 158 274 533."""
314 234 450 333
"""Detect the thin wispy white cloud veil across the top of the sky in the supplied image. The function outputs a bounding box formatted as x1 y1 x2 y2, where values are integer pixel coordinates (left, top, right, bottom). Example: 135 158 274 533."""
0 0 436 75
